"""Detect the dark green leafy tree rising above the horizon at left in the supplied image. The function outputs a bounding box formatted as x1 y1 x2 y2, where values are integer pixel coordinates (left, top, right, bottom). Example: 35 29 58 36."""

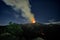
6 22 23 36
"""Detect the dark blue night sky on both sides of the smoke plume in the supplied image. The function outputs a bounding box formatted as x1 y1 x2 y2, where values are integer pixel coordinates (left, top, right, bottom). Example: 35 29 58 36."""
0 0 60 25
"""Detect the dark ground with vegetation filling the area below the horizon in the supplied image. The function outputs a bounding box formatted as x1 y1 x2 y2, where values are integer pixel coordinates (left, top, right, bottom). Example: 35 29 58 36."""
0 22 60 40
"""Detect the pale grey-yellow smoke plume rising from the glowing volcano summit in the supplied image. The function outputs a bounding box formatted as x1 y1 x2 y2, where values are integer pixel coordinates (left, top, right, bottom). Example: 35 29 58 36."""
3 0 34 21
